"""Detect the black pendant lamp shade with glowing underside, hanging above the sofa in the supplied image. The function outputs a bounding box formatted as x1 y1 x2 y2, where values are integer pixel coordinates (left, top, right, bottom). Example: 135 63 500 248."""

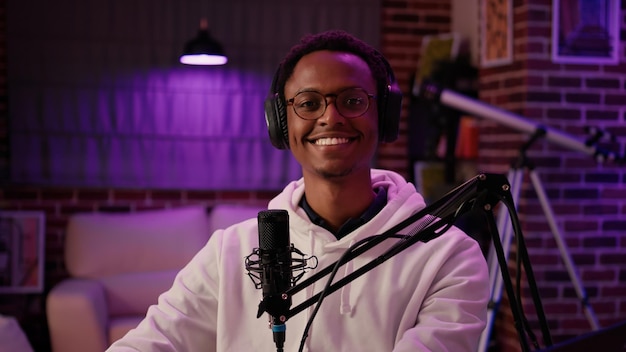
180 19 228 65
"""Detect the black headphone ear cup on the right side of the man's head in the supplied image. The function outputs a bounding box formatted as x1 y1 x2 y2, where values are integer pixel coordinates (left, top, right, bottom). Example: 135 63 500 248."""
378 81 402 143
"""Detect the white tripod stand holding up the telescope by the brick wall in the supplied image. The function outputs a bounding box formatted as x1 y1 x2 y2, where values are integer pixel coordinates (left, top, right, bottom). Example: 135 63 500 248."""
478 133 600 351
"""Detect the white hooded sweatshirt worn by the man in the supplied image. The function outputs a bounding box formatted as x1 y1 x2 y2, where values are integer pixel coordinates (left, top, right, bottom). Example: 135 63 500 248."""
107 170 489 352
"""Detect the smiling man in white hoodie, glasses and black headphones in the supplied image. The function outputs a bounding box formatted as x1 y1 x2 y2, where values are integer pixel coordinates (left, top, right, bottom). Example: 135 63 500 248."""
109 31 489 352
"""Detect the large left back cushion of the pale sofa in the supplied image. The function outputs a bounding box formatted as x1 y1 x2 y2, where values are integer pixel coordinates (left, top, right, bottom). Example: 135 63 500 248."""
65 206 210 278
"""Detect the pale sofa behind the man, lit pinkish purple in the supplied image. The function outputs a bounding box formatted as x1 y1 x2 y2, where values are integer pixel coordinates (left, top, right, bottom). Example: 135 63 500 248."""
46 205 263 352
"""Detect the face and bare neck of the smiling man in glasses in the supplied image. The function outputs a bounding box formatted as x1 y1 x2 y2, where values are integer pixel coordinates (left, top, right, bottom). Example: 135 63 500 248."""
284 50 378 232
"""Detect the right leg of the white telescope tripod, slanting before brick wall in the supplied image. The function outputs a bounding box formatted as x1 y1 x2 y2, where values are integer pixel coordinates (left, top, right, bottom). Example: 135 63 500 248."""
529 170 600 330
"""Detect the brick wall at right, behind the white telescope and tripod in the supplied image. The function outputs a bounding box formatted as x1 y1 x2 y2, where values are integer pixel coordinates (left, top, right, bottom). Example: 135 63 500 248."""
472 0 626 351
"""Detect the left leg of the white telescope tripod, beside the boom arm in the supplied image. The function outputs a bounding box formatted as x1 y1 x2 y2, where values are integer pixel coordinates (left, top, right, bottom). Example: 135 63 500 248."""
478 168 524 351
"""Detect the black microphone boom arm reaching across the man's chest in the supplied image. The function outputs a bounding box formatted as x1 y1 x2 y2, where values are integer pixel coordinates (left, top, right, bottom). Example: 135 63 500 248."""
272 174 551 351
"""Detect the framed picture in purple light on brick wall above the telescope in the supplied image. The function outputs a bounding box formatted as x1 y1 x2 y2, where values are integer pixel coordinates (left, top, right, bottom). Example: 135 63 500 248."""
551 0 621 64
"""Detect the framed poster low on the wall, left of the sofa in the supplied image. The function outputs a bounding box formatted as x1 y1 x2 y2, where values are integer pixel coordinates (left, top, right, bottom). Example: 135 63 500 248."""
0 211 44 293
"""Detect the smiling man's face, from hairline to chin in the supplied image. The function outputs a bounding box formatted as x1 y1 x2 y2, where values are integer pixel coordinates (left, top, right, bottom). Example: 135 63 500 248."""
285 51 378 178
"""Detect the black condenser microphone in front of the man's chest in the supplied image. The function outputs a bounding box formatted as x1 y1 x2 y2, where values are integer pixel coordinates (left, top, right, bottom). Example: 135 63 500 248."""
257 209 293 352
